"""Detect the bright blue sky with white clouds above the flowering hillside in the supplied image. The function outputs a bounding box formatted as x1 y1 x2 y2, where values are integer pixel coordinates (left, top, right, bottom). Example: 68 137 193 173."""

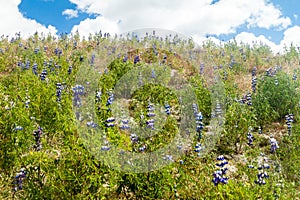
0 0 300 53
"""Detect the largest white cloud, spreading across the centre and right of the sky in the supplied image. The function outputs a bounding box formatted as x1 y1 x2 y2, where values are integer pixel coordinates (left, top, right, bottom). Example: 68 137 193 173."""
70 0 291 36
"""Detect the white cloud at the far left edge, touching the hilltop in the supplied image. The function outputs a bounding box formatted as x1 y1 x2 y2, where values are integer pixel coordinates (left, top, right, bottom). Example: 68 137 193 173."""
0 0 57 37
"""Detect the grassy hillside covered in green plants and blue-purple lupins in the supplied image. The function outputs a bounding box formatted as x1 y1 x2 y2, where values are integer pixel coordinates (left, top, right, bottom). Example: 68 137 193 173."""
0 33 300 199
